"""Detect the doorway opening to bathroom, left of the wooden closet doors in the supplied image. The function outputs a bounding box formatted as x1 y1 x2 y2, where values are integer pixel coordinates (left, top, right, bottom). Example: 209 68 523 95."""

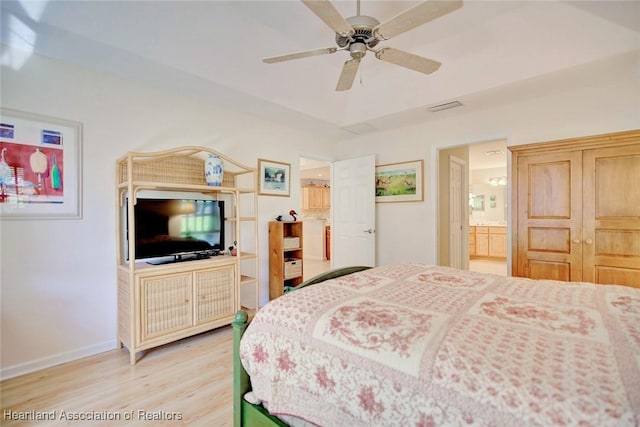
438 139 510 275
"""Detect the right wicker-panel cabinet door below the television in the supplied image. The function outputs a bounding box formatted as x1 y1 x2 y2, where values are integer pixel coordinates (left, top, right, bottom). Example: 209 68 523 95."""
195 265 237 325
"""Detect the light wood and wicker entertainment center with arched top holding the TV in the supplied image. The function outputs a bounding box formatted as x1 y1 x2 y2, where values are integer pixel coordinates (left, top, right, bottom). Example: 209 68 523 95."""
116 147 258 364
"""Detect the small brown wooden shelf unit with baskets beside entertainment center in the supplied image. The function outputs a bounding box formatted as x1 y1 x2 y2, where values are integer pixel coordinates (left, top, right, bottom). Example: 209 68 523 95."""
269 221 304 300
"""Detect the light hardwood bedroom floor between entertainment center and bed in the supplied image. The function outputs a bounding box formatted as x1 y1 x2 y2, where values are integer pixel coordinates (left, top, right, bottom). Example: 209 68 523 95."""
0 326 233 427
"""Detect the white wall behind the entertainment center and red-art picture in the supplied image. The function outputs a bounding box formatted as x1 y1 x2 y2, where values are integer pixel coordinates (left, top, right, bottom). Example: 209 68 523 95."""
0 52 334 378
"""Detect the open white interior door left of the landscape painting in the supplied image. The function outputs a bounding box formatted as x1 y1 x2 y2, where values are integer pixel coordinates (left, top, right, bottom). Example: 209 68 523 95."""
331 154 376 268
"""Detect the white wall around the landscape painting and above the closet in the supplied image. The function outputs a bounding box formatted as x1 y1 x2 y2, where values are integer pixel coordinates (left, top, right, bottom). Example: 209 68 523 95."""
338 73 640 265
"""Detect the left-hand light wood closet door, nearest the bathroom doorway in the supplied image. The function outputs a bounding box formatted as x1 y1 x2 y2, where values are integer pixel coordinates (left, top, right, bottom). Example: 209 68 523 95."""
514 151 582 281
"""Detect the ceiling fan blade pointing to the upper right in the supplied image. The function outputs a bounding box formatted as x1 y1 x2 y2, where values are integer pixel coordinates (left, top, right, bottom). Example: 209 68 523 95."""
373 0 462 40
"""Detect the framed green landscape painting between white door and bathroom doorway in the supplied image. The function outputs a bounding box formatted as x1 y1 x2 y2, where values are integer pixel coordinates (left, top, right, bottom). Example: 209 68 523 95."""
376 160 424 202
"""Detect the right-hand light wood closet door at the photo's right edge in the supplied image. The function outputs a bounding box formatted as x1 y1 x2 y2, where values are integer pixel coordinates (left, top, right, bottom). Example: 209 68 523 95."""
583 143 640 287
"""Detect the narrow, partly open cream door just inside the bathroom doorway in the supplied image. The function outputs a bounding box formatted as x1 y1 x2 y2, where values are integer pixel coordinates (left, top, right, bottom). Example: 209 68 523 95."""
449 156 467 269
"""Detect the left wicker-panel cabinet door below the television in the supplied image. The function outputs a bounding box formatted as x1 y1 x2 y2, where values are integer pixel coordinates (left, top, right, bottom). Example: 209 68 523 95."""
140 272 193 342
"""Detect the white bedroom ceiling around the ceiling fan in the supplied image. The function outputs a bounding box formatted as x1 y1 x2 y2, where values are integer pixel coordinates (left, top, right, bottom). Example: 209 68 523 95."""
0 0 640 136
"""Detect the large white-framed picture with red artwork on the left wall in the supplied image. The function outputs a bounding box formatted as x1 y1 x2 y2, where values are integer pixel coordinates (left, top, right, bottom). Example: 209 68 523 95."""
0 108 82 220
